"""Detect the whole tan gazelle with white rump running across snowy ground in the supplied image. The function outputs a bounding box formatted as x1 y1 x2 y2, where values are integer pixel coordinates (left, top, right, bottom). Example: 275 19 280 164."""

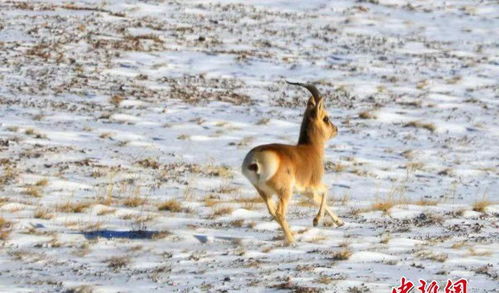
242 82 343 244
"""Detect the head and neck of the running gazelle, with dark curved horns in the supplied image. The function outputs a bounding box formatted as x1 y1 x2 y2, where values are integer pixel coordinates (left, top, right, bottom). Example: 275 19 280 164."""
288 82 338 144
